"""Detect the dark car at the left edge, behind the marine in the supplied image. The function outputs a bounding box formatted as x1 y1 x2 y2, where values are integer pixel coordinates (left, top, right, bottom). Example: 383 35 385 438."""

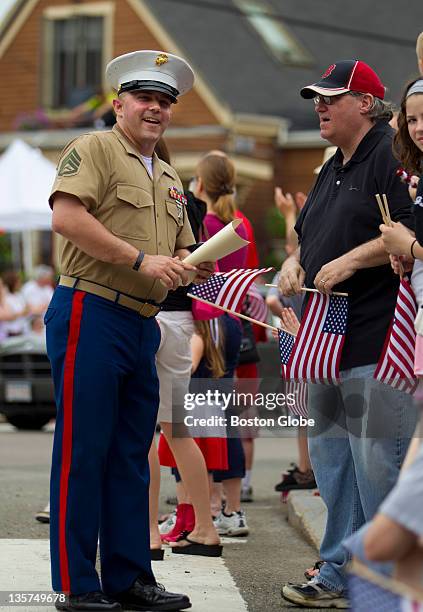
0 333 56 430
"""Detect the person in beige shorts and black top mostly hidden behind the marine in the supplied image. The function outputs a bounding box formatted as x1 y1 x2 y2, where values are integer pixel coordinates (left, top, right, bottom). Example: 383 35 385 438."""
149 141 220 560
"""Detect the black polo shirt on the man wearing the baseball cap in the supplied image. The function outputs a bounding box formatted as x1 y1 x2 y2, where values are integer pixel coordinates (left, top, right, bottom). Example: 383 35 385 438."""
295 121 412 369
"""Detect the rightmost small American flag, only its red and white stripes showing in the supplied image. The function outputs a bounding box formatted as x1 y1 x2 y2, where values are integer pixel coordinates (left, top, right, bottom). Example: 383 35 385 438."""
373 277 417 393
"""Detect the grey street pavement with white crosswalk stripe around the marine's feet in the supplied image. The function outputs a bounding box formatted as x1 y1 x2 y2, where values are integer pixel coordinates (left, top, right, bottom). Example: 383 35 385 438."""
0 423 316 612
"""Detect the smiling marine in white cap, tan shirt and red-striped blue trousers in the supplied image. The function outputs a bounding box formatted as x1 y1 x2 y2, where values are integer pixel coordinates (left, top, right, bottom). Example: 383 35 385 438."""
45 51 212 610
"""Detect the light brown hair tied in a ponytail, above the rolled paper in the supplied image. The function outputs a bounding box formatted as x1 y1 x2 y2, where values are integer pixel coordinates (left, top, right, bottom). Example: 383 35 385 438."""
197 153 236 223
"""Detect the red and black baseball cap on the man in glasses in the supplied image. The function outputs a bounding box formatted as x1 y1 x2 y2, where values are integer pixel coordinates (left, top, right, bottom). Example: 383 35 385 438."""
300 60 385 100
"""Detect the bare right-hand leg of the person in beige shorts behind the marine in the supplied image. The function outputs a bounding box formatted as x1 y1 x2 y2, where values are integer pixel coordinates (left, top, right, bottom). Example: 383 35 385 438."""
160 423 220 546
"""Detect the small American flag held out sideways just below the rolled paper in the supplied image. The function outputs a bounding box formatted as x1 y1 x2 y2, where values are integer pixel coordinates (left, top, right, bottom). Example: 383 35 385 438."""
190 268 273 312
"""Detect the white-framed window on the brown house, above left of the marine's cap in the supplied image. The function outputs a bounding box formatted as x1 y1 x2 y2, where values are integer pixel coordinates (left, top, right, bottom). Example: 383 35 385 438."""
42 2 113 109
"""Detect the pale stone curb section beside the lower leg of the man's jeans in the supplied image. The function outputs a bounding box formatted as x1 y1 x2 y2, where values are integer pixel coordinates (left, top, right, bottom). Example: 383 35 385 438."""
287 491 327 551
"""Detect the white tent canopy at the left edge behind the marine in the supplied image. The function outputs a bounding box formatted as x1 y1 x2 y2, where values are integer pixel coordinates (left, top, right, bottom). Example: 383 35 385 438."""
0 140 56 232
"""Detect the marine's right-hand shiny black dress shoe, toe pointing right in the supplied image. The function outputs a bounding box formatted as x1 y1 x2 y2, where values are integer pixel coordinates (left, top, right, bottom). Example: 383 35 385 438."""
114 576 191 612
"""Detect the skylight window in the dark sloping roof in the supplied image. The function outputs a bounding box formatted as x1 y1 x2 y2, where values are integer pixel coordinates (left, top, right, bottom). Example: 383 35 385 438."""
233 0 313 66
